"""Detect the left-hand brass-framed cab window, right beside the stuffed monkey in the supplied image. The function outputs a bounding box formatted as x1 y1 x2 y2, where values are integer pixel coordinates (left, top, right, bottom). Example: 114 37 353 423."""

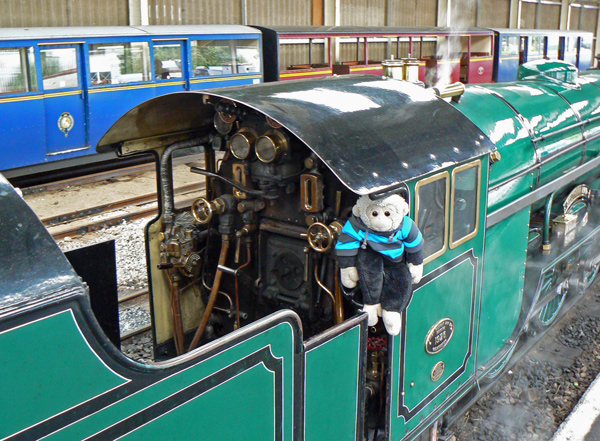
415 172 449 263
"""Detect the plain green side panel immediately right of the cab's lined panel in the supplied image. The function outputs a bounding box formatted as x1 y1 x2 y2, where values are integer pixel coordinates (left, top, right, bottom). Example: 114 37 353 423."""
477 207 529 365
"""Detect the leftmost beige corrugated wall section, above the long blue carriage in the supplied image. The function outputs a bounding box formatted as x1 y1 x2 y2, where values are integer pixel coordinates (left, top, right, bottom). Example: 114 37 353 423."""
0 0 129 28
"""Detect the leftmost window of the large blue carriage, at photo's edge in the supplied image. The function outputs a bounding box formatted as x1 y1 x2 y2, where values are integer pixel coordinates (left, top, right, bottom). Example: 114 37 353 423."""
0 47 37 94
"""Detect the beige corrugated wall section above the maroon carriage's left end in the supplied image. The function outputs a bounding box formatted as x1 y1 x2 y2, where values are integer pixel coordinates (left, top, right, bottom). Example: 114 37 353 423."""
248 0 312 26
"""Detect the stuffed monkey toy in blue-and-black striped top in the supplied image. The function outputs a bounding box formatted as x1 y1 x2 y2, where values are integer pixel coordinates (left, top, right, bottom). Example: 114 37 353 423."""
335 194 423 335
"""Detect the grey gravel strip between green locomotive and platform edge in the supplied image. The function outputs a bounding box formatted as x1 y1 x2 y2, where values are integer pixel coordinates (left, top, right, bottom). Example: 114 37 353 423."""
450 282 600 441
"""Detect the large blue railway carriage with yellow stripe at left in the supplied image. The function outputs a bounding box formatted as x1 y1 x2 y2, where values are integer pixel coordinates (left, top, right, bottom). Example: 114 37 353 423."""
0 25 262 177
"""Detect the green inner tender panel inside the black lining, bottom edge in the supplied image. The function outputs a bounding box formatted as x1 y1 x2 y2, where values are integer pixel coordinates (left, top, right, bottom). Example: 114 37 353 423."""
121 364 277 441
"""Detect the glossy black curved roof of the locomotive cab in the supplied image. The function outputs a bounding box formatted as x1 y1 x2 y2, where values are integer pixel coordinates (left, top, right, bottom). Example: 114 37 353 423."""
98 75 495 195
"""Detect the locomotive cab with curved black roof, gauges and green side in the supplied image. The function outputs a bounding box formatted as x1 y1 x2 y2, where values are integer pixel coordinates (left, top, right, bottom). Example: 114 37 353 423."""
100 75 494 439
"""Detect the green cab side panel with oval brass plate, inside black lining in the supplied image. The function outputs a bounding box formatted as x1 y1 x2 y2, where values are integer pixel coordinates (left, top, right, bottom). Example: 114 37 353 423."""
401 259 475 409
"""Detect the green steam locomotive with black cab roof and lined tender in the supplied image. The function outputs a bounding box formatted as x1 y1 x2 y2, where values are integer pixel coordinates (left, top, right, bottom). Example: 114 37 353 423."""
0 61 600 441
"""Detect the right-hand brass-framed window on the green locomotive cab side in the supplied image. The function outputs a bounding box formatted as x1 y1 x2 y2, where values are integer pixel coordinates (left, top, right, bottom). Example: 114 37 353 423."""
450 161 481 248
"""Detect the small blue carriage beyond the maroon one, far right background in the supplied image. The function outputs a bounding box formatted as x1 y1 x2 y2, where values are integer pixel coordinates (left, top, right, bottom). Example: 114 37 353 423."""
492 28 594 82
